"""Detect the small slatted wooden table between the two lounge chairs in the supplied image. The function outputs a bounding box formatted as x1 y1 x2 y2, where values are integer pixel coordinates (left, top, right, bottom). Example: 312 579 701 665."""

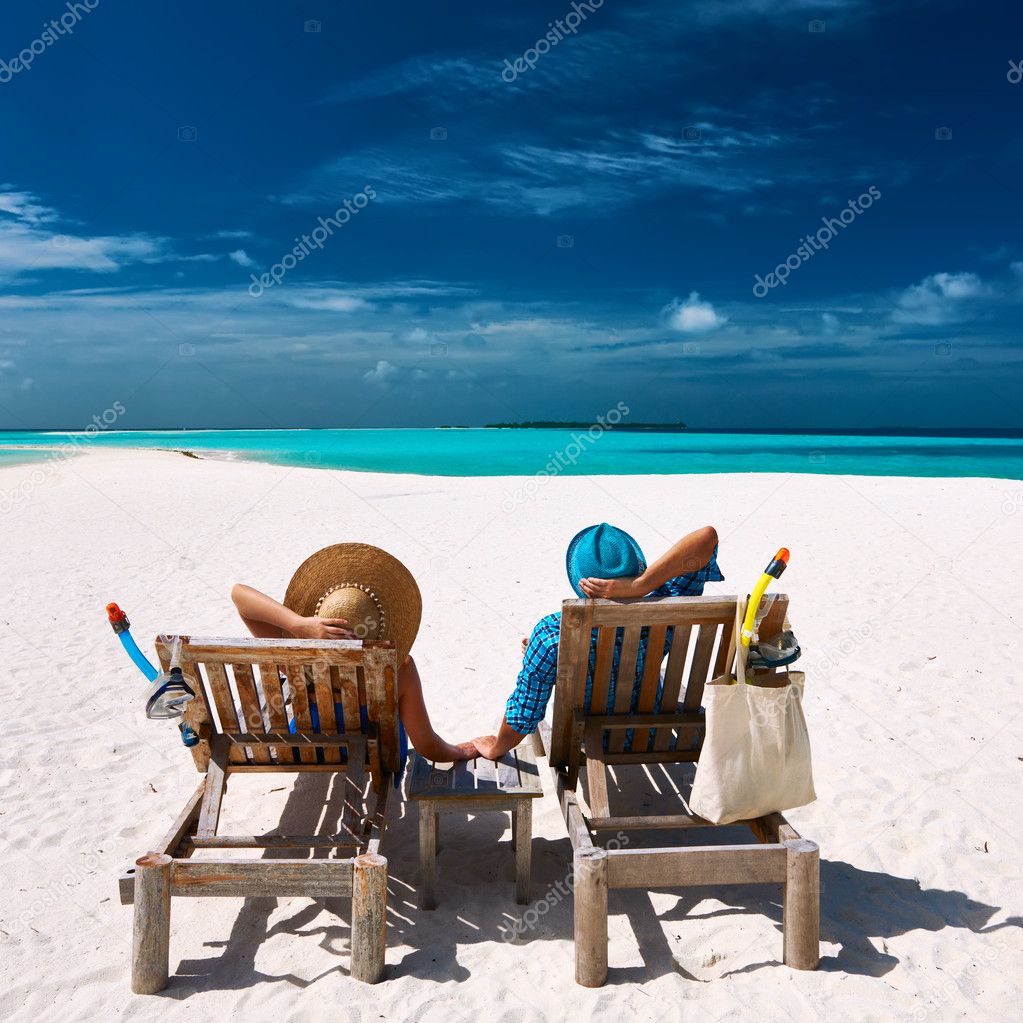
408 740 543 909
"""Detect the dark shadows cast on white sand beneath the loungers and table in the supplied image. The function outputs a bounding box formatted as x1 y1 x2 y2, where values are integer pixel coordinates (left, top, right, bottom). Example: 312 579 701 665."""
155 767 1023 998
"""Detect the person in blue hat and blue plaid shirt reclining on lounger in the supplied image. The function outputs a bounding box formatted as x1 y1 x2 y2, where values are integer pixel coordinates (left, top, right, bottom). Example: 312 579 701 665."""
464 523 724 760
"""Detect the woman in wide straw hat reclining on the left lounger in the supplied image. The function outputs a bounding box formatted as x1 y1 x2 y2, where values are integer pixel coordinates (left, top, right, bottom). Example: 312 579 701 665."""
231 543 477 761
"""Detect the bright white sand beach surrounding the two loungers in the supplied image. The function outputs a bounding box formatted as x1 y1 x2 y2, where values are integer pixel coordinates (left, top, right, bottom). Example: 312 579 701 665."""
0 449 1023 1023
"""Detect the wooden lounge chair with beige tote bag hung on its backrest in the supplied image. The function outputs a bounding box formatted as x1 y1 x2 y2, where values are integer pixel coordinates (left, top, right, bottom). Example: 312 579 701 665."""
543 594 819 987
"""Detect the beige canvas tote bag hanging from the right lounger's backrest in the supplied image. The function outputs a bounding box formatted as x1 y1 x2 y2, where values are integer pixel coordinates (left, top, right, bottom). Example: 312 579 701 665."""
690 601 817 825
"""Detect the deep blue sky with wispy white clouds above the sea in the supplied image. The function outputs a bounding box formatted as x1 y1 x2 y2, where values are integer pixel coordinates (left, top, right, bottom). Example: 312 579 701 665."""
0 0 1023 429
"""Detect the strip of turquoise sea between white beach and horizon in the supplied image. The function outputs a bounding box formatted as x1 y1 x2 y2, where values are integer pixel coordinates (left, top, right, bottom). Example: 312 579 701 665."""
0 429 1023 480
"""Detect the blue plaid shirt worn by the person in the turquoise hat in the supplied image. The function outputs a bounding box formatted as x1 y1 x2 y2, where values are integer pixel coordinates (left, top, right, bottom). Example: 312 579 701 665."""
504 547 724 736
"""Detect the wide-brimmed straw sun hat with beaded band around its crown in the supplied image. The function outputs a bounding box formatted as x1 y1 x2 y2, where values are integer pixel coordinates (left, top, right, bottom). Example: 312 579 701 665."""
284 543 422 663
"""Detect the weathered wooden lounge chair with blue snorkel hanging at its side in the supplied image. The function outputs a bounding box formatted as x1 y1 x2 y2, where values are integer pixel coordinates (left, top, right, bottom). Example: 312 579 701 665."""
120 636 399 994
